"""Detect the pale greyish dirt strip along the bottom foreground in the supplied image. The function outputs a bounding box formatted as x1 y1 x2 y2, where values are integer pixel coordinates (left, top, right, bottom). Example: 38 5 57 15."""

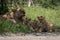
0 33 60 40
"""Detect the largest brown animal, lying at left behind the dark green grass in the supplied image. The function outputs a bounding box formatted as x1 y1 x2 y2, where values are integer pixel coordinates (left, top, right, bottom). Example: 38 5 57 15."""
2 9 25 24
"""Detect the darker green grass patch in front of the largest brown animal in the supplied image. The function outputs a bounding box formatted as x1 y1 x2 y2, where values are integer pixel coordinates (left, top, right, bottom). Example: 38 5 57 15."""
0 20 31 33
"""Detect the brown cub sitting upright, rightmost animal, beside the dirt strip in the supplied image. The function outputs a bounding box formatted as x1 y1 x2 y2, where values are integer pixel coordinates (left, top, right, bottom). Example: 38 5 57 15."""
38 16 54 32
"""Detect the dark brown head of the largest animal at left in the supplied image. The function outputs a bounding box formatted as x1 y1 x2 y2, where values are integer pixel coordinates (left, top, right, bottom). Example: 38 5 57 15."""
14 9 25 21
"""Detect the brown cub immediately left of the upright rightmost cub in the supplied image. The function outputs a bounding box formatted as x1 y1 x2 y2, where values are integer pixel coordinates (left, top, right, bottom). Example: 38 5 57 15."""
31 20 43 32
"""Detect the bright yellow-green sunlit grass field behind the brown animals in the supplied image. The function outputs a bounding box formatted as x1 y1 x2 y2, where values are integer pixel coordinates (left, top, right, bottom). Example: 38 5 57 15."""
24 6 60 28
